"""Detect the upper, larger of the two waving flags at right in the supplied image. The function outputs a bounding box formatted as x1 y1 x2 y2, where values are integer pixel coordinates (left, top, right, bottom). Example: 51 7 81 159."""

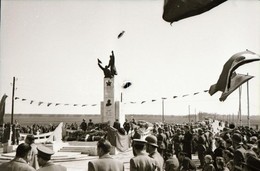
209 51 255 96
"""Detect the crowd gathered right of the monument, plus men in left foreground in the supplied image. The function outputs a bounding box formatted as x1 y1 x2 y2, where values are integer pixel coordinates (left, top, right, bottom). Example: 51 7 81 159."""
0 120 260 171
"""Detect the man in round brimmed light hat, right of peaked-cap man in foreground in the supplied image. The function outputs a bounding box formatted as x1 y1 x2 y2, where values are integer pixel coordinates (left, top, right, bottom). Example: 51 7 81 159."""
145 135 164 171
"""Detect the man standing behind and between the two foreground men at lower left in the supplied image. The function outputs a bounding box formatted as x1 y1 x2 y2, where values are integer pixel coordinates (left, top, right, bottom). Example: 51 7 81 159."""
24 134 39 170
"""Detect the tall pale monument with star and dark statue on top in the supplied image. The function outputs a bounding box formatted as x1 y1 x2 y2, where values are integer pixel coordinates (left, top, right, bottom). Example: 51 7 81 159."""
98 51 125 126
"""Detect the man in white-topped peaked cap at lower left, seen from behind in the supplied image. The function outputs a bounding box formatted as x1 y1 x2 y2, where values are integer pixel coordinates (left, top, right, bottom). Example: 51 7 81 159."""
37 145 67 171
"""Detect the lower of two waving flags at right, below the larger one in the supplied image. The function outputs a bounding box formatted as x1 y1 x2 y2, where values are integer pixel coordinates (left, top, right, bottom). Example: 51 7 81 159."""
219 73 253 101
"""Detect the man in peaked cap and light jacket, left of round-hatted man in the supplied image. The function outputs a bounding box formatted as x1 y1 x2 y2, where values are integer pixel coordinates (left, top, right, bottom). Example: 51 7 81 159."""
130 139 157 171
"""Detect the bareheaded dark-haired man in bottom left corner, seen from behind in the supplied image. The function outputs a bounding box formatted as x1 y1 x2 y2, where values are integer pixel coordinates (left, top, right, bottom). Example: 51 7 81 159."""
0 143 36 171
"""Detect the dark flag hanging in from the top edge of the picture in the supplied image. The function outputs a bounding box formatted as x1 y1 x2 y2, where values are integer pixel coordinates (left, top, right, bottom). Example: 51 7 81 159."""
162 0 227 23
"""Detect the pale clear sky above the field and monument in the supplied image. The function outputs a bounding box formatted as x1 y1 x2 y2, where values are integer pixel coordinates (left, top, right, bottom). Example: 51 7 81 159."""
0 0 260 115
